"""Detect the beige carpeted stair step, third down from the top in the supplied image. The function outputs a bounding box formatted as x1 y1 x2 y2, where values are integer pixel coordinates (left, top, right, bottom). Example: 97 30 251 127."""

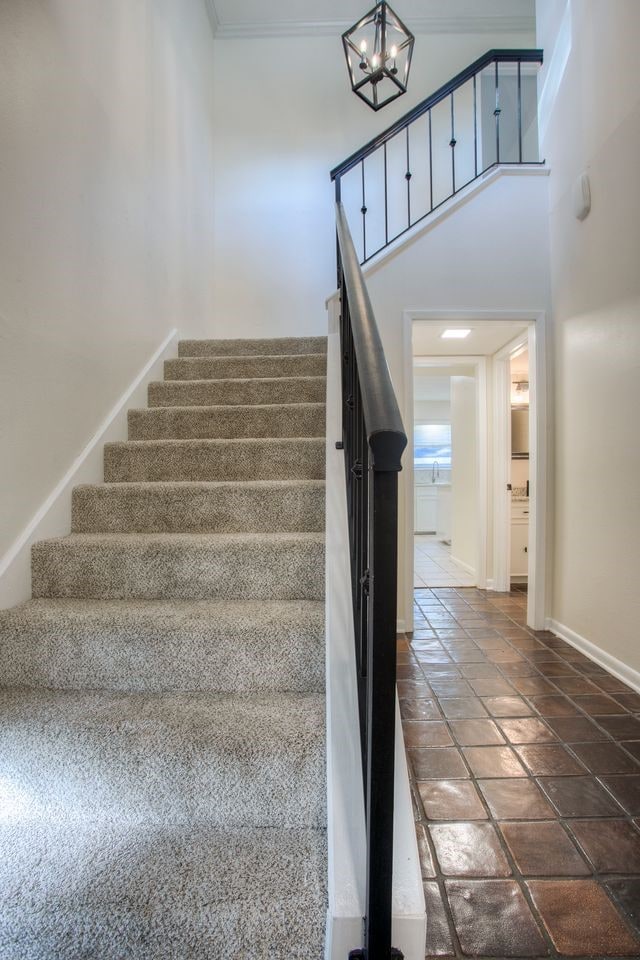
147 377 327 407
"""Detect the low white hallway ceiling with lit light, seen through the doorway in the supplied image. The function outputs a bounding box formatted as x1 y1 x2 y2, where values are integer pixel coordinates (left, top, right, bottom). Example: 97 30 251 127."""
413 320 527 357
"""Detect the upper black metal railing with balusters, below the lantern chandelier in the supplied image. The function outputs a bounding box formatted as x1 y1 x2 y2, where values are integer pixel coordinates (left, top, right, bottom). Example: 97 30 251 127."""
331 50 542 263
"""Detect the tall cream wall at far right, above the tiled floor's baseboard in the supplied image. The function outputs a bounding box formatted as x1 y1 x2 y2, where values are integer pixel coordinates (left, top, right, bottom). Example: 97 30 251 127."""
538 0 640 670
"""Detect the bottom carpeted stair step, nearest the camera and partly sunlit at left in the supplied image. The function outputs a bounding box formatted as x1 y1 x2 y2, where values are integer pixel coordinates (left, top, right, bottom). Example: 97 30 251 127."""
0 821 327 960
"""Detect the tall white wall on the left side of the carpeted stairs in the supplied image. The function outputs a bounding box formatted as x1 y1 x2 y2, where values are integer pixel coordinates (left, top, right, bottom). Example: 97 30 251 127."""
0 0 218 559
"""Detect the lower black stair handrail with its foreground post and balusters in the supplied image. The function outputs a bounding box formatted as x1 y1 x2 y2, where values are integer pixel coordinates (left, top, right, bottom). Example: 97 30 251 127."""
336 197 407 960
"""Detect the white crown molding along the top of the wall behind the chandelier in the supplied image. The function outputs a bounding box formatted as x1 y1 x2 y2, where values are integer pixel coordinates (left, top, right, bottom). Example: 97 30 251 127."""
211 15 535 39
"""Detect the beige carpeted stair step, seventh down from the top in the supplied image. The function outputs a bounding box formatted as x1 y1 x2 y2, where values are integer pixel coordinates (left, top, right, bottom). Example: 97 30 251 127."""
31 533 324 600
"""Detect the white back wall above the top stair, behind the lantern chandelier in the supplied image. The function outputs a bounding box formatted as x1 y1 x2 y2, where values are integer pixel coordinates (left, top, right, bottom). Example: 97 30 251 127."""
211 34 534 336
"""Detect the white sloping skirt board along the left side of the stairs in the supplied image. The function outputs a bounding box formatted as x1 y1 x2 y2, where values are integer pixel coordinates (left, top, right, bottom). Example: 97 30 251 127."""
0 329 178 609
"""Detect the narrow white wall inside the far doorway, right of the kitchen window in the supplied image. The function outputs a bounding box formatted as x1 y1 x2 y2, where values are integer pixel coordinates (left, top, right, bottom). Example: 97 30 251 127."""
451 377 480 572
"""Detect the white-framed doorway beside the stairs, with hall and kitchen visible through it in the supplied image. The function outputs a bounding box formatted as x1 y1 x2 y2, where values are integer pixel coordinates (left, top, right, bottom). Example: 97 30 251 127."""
403 311 547 631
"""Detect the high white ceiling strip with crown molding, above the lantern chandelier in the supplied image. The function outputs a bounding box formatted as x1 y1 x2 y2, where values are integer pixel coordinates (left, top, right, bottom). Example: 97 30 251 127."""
205 0 535 37
